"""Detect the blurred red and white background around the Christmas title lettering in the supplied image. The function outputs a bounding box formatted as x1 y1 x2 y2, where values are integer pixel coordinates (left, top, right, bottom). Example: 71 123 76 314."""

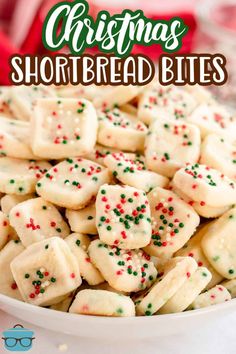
0 0 236 104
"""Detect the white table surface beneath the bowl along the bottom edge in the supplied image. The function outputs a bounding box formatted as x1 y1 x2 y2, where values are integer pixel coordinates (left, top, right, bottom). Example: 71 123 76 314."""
0 311 236 354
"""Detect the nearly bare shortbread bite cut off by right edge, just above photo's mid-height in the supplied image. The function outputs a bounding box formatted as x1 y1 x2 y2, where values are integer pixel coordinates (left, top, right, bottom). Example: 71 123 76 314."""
200 134 236 180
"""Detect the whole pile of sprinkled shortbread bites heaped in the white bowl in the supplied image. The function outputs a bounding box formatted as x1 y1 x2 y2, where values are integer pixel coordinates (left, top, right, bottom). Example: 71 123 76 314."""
0 79 236 317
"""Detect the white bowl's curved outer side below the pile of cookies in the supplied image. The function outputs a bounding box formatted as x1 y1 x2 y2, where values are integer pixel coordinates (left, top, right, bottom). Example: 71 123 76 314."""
0 294 236 340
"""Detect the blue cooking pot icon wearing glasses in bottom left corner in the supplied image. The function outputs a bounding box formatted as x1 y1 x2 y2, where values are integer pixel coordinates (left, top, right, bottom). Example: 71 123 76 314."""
2 324 35 352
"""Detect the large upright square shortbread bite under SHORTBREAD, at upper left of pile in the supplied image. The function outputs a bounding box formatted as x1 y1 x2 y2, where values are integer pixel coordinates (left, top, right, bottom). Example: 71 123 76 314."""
31 98 98 159
